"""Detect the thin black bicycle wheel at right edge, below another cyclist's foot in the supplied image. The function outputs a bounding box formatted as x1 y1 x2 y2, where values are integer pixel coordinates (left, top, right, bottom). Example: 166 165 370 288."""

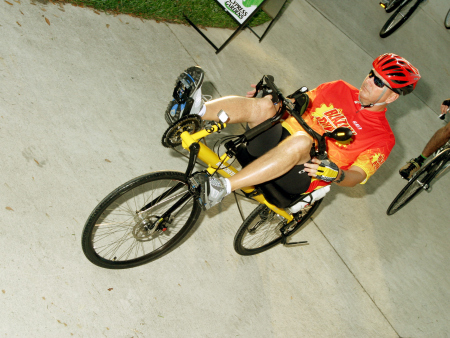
386 150 450 216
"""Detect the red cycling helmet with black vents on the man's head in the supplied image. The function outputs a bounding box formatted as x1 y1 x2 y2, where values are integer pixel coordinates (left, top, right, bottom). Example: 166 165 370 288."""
372 53 420 95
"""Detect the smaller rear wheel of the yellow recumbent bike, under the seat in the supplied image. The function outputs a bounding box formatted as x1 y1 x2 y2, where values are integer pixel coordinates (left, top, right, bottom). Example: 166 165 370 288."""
234 200 322 256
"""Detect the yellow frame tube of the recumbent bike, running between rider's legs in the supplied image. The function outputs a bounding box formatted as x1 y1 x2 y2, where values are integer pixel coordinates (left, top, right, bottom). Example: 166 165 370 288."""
180 123 294 222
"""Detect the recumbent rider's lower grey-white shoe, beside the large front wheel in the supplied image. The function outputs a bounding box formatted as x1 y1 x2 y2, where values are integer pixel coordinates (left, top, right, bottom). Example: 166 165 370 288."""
193 173 227 210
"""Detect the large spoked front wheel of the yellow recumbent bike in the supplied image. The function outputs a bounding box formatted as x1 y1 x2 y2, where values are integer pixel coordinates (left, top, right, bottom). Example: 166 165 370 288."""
81 171 201 269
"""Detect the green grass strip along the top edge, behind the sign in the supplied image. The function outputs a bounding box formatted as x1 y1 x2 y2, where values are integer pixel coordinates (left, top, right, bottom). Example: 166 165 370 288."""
64 0 271 28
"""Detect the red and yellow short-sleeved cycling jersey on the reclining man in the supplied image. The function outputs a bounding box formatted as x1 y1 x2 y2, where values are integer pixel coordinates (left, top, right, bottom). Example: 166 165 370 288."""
285 80 395 184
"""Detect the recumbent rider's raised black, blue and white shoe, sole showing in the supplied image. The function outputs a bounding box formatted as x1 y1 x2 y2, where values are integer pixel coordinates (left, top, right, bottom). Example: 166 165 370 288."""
165 66 205 124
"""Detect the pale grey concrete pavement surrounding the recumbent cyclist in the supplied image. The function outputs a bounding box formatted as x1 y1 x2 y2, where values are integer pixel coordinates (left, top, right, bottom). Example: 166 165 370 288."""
0 0 450 337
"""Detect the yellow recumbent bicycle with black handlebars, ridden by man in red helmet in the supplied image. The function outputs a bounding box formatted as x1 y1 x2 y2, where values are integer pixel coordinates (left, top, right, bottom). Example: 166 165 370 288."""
82 76 352 269
